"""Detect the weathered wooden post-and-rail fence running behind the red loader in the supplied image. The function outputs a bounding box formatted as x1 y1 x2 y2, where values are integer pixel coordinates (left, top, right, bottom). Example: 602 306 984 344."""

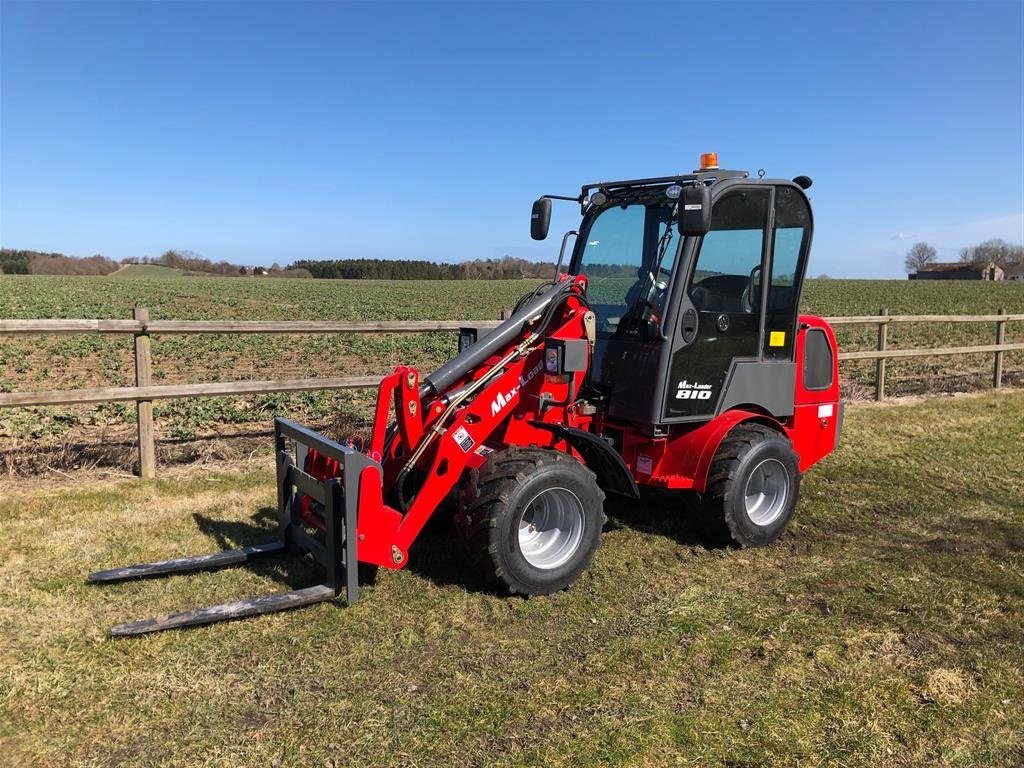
0 307 1024 477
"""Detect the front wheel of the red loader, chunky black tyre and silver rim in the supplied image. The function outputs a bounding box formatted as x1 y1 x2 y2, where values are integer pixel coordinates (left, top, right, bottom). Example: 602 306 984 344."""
456 446 606 595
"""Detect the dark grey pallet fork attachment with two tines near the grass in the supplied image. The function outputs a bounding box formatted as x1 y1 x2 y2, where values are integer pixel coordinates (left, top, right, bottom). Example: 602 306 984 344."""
88 419 381 637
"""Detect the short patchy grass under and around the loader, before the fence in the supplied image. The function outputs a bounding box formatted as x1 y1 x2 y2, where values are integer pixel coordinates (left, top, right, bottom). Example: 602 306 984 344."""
0 392 1024 768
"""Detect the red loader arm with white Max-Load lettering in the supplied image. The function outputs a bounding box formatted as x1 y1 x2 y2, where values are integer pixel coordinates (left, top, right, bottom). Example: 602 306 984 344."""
357 276 588 568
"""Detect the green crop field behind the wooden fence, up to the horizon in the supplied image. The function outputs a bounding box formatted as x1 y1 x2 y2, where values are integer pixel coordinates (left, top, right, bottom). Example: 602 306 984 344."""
0 267 1024 471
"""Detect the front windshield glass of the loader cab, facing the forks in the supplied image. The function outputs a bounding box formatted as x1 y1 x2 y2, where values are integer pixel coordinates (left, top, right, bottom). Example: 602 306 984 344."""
577 198 679 333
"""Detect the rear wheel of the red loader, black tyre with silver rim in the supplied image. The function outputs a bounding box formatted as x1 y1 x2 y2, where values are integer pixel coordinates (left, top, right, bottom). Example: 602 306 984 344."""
703 424 800 547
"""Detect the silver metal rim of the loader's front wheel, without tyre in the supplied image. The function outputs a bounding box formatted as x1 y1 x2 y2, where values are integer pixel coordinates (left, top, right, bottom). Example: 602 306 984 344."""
519 488 583 570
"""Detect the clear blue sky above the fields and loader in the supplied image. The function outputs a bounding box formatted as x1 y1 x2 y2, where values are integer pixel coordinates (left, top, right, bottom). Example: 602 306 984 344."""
0 0 1024 278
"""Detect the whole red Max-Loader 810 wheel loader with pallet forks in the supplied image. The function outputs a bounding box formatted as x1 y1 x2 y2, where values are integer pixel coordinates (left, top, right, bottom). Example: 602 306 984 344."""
90 155 843 635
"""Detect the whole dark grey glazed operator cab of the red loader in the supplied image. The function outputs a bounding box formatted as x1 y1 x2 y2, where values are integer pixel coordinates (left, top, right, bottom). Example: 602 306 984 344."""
569 169 812 433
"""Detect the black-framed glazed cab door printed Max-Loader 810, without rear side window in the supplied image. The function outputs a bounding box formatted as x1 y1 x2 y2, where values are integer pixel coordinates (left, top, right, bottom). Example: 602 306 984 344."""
664 185 772 421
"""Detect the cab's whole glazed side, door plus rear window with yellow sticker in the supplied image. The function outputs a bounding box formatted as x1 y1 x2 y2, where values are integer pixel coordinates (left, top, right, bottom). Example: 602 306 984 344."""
664 181 813 422
